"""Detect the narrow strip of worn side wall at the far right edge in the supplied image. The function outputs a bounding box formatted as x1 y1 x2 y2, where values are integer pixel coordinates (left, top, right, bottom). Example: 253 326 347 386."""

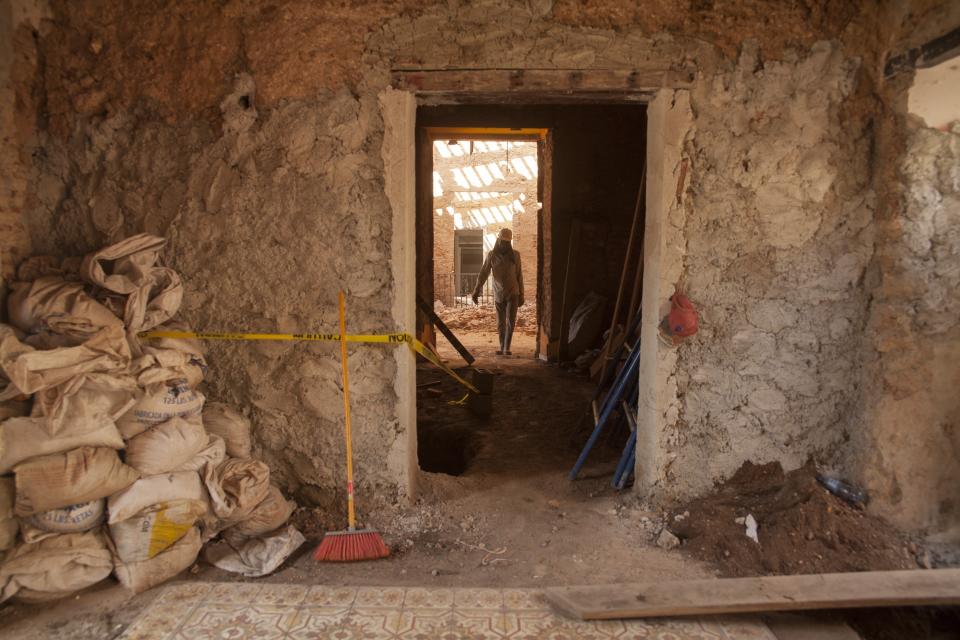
856 118 960 542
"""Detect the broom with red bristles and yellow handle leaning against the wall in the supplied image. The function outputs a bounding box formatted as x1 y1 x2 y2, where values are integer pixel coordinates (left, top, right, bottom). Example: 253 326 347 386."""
313 291 390 562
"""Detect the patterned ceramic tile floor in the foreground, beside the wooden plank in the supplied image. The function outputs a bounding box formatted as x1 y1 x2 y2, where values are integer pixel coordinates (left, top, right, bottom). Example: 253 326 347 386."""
123 582 775 640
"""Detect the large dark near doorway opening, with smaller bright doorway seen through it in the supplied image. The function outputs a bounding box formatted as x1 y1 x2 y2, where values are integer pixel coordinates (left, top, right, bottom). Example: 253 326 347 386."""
416 102 646 481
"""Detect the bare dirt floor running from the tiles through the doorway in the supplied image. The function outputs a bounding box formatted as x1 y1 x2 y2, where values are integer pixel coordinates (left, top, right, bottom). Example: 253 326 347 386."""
0 332 713 640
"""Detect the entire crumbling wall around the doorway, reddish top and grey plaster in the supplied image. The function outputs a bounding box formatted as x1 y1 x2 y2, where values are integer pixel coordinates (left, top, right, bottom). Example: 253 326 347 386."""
15 0 944 524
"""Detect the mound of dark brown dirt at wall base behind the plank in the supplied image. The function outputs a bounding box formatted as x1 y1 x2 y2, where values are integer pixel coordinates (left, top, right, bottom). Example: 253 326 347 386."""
668 461 917 576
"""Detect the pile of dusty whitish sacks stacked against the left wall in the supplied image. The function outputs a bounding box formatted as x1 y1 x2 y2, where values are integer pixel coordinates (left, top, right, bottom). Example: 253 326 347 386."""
0 234 304 601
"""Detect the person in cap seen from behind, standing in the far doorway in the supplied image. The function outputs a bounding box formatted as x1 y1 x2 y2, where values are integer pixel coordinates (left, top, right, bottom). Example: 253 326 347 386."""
473 228 523 356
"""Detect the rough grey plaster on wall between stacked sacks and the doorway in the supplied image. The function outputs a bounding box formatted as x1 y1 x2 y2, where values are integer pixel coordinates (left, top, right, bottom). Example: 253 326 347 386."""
23 74 409 502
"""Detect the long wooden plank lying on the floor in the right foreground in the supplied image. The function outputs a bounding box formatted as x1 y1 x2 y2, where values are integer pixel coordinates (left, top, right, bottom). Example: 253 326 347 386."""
545 569 960 620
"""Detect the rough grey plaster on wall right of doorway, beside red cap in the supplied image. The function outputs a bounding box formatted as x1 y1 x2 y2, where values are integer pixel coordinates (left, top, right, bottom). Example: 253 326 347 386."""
659 43 873 500
